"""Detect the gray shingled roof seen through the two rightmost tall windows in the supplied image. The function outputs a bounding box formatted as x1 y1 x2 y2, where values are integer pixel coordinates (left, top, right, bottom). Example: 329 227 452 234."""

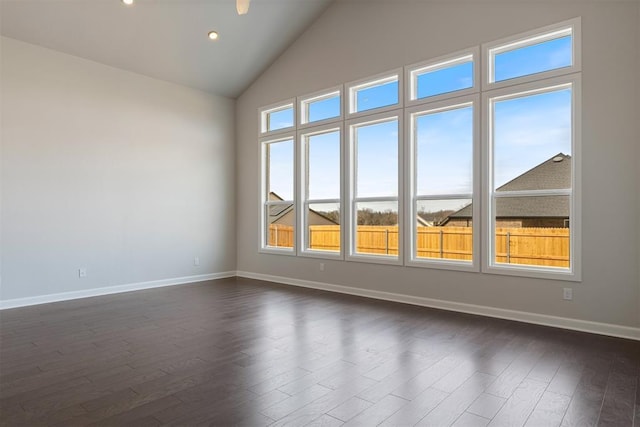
443 153 571 223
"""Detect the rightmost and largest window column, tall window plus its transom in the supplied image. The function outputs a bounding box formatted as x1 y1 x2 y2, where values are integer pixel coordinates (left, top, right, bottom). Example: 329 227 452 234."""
484 21 580 278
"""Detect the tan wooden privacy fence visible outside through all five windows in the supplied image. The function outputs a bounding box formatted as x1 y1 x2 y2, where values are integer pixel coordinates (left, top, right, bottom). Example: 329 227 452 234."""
269 224 570 267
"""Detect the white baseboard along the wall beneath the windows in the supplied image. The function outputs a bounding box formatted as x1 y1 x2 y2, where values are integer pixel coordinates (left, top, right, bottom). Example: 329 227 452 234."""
237 271 640 340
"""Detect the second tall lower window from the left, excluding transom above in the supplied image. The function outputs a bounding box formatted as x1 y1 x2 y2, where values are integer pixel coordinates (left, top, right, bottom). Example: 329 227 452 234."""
300 126 342 256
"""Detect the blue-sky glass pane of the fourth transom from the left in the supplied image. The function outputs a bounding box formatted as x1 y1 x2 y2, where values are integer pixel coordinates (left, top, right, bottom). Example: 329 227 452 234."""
416 61 473 99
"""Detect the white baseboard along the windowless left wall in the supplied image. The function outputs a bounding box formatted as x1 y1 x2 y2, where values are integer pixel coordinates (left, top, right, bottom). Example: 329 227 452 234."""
0 271 236 310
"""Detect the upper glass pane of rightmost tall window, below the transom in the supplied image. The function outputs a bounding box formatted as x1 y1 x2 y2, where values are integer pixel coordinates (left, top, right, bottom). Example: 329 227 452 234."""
493 89 572 191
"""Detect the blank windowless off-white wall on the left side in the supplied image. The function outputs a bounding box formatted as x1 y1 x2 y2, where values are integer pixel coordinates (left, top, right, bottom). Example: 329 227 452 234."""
0 38 236 301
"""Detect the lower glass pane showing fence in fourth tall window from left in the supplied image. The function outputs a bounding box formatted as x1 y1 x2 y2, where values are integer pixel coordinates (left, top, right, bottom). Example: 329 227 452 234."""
415 199 473 261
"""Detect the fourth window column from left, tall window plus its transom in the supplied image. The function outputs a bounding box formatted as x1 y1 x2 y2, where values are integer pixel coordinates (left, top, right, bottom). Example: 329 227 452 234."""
407 49 479 270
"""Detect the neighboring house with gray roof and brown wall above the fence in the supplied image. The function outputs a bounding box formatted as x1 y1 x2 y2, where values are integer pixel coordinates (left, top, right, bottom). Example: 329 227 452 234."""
439 153 571 228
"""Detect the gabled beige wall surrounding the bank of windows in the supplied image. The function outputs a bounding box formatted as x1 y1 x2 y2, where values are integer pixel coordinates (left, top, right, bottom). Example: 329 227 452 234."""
236 0 640 327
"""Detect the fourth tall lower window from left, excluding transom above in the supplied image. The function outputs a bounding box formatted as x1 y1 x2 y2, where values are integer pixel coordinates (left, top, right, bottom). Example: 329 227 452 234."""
409 98 478 269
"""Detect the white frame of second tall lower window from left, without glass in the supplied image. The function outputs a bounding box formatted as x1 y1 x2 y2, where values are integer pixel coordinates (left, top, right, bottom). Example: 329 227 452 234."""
296 121 345 260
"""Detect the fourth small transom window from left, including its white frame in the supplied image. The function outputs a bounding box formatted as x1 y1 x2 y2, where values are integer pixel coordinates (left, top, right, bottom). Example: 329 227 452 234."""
407 49 477 104
